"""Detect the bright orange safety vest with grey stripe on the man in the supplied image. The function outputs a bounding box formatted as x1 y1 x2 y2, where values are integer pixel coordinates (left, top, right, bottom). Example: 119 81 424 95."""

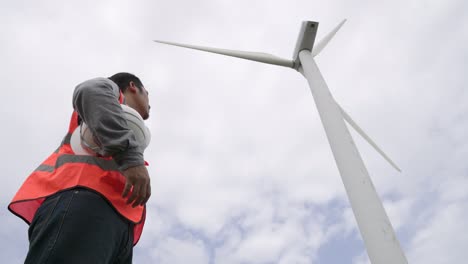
8 93 146 245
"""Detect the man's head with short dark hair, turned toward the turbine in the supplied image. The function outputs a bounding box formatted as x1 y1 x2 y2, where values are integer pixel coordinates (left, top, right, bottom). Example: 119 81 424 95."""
109 72 150 120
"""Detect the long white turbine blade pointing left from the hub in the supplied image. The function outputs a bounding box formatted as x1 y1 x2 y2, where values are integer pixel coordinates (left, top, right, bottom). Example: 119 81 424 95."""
154 40 294 68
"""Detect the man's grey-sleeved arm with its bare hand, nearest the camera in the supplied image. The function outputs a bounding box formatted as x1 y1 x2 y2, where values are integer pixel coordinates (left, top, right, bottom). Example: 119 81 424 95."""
73 78 151 207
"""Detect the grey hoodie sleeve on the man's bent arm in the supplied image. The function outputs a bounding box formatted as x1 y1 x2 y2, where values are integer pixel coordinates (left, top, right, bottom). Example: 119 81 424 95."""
73 78 145 170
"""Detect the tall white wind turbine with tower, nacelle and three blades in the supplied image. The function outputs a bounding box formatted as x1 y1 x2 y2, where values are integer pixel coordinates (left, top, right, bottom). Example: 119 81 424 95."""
155 20 408 264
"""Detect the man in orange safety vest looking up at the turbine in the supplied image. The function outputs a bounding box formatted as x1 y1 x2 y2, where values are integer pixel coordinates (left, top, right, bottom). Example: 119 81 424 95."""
8 73 151 264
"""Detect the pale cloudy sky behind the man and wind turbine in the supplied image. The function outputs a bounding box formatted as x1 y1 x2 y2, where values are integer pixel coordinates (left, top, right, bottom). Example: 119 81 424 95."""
0 0 468 264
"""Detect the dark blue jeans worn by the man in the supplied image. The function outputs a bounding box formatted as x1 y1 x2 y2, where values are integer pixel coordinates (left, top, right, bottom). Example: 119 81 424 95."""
25 188 133 264
